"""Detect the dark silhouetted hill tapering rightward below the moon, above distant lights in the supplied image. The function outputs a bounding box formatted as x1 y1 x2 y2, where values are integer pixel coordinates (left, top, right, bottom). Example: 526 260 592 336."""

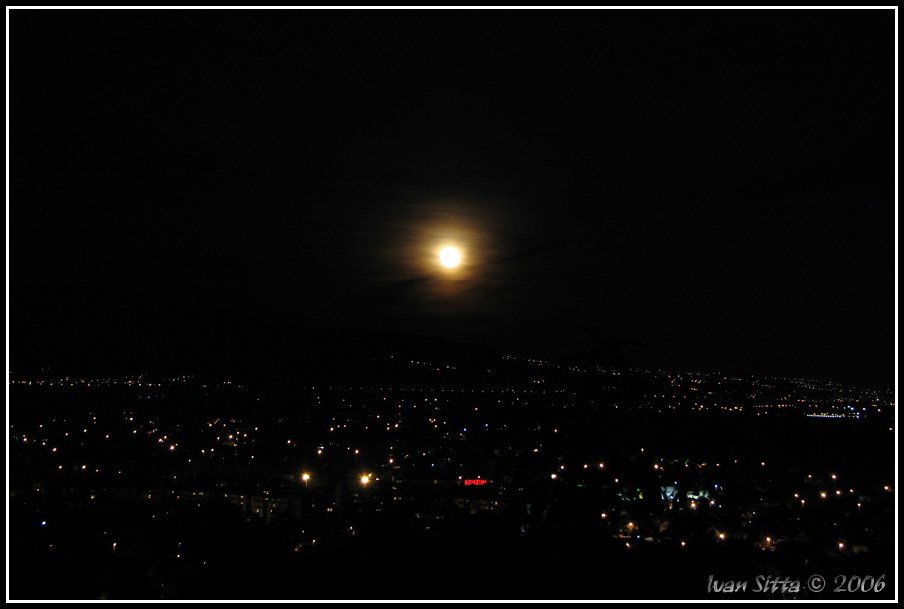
10 282 499 377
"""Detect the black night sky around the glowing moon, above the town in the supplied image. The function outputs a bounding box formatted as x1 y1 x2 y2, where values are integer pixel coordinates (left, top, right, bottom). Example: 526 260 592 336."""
14 10 896 387
